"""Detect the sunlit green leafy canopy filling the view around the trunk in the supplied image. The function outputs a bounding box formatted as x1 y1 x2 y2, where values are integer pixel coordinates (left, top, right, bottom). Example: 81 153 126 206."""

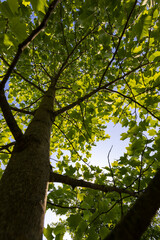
0 0 160 240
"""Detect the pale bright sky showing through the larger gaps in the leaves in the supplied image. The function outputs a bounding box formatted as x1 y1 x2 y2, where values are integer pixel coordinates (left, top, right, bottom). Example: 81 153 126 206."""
43 123 129 240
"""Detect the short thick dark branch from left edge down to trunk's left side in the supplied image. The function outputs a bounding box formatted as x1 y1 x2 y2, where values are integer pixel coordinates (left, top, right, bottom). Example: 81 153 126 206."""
0 90 23 141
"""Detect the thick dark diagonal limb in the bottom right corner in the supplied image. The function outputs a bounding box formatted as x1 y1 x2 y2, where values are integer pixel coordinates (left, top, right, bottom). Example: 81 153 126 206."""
104 169 160 240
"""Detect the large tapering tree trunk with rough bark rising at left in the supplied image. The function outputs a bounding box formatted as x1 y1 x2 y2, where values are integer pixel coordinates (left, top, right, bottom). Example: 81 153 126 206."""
0 87 54 240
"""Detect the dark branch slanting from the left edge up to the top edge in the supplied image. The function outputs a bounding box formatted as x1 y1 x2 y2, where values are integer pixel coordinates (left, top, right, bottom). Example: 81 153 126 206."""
0 0 60 89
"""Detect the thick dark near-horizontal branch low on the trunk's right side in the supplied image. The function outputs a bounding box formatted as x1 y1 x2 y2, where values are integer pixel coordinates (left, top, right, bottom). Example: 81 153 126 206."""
50 172 136 197
